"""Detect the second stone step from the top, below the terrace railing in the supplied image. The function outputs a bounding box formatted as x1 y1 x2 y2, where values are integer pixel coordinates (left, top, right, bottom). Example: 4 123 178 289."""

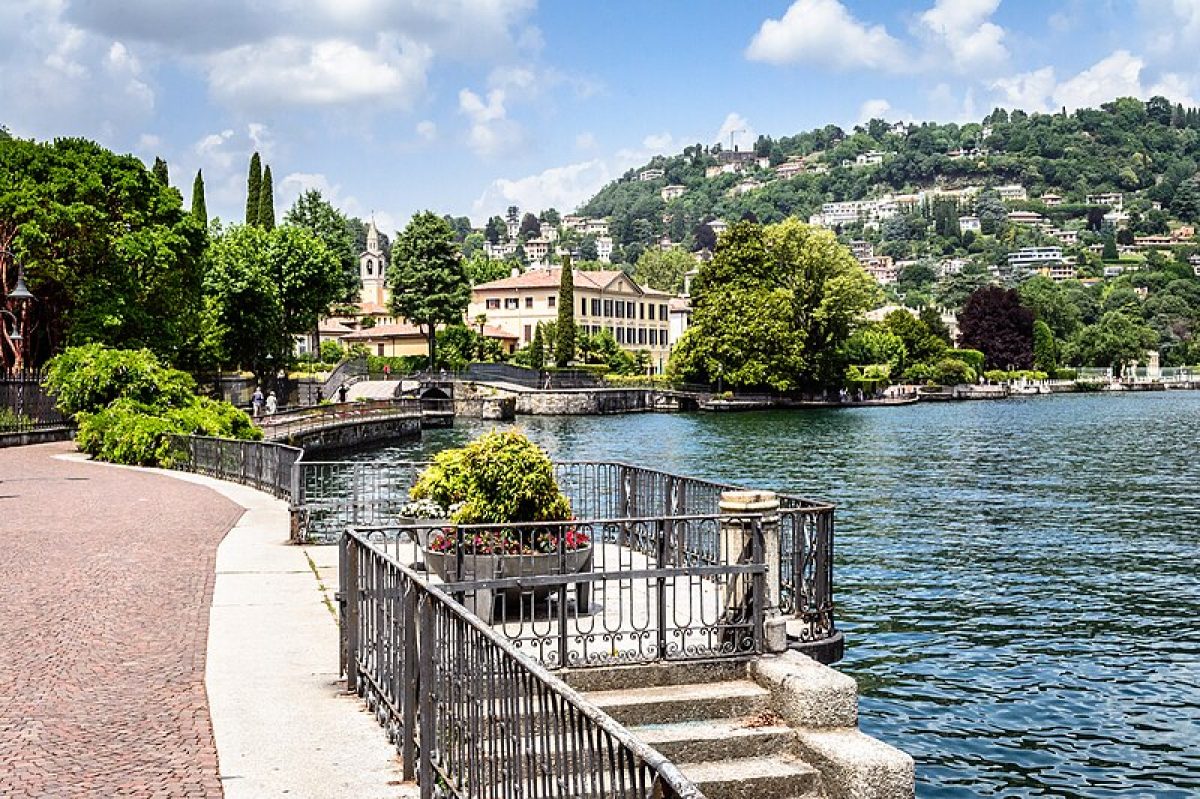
584 680 770 726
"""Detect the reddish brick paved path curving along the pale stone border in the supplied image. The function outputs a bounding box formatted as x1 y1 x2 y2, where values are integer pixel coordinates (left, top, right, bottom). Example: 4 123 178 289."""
0 444 241 797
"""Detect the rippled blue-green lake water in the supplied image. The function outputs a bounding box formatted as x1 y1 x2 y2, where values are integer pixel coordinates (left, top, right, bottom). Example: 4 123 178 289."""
360 392 1200 798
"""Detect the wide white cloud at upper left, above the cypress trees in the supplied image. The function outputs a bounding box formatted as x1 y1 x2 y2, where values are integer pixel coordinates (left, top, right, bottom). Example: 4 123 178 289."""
209 35 432 109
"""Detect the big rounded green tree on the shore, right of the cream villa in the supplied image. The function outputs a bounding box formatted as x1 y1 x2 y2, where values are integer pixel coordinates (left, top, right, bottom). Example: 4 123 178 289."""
671 220 880 391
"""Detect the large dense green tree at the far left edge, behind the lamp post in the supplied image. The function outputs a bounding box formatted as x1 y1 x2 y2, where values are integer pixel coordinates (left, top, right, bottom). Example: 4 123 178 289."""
0 139 205 364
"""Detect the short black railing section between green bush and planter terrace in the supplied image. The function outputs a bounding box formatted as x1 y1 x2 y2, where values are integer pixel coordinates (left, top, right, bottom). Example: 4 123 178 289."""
172 435 304 499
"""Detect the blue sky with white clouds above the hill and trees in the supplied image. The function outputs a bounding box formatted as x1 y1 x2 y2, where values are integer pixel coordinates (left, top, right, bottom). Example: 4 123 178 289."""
0 0 1200 230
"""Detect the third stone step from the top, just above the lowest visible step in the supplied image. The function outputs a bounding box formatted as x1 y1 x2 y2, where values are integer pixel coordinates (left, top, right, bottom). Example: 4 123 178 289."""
629 716 796 763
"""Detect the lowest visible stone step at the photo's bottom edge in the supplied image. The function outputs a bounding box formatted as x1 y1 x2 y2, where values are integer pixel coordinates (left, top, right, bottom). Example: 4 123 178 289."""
679 757 824 799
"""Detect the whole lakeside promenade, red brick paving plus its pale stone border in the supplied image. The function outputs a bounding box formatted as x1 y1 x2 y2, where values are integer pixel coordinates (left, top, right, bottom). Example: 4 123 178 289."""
0 444 413 799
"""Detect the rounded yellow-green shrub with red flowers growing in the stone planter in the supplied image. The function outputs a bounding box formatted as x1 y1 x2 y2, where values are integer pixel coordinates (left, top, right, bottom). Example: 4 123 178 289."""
409 431 590 554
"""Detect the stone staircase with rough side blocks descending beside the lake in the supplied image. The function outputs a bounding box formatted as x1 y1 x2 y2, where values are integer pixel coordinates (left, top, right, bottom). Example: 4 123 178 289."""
563 653 913 799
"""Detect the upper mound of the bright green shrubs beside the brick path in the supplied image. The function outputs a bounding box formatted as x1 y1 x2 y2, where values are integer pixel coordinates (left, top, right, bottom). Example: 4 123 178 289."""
46 344 196 416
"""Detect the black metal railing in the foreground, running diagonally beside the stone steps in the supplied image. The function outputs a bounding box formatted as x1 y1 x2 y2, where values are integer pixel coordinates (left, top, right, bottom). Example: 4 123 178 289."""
340 530 702 799
